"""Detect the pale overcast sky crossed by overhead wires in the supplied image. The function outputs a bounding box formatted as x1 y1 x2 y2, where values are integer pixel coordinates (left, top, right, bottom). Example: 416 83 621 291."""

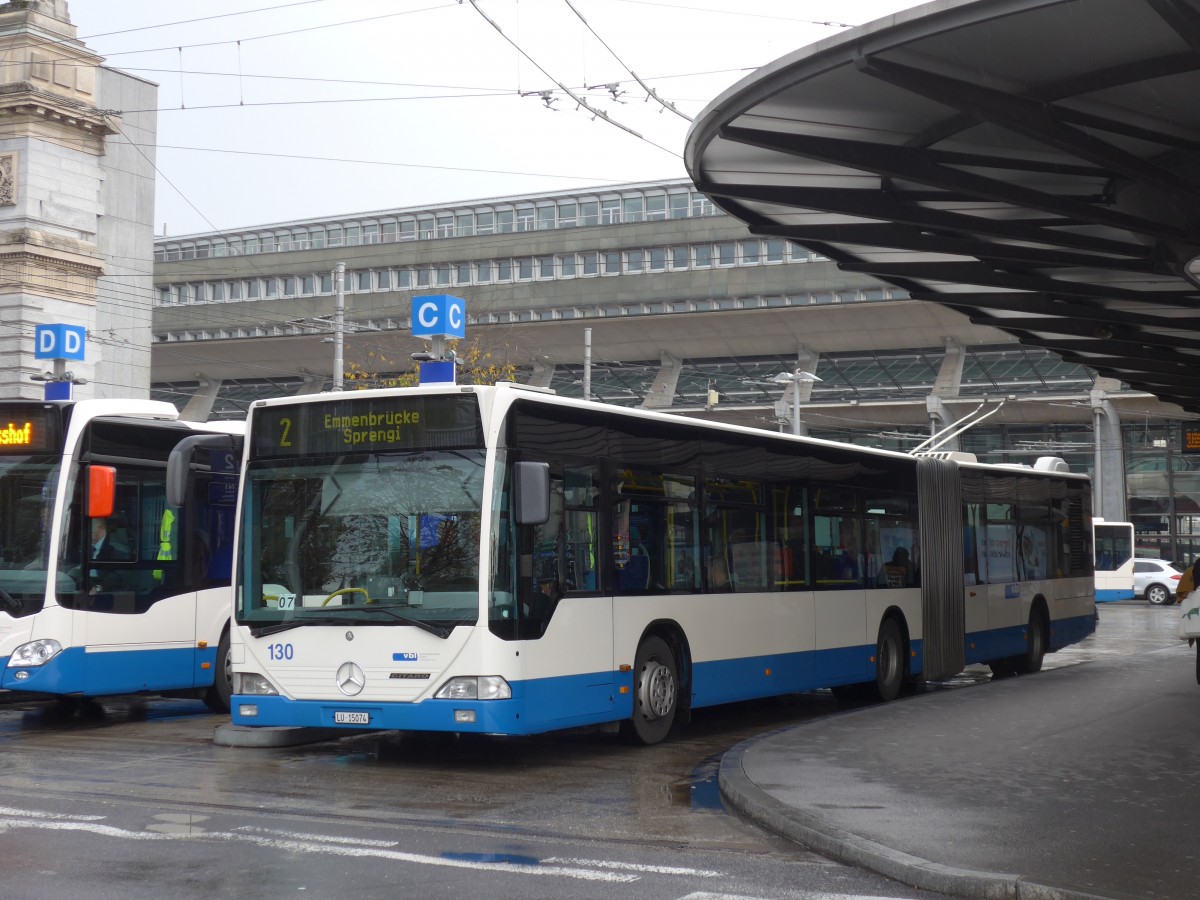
68 0 918 235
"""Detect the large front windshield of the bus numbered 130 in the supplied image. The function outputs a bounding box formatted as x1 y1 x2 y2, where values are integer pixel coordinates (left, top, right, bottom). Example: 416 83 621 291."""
238 450 484 634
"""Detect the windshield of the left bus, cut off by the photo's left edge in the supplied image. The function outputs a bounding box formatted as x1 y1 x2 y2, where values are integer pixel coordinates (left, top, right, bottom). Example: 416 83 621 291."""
0 456 59 616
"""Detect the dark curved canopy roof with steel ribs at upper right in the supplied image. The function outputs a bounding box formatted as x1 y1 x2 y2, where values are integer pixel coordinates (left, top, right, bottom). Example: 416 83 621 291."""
685 0 1200 413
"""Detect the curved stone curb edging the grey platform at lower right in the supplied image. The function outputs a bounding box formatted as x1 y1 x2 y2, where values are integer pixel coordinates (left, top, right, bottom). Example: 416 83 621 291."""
718 726 1105 900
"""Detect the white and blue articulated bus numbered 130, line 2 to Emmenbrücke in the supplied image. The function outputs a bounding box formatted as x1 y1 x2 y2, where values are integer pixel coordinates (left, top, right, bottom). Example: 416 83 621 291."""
232 385 1096 744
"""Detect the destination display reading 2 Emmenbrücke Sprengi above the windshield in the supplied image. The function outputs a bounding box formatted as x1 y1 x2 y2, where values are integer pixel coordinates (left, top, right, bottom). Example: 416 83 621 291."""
251 394 484 457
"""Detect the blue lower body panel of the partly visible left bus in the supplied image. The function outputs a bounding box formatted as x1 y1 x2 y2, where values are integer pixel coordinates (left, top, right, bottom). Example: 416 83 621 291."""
0 647 206 697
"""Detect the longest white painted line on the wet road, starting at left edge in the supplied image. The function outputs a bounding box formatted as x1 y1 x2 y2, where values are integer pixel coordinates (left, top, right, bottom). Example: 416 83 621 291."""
0 810 640 883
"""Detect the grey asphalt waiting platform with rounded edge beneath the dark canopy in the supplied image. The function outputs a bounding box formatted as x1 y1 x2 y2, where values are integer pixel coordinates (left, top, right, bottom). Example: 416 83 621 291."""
720 601 1200 899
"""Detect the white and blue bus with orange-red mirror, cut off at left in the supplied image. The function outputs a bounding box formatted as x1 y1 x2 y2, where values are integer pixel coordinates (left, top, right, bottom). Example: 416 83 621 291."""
0 400 245 709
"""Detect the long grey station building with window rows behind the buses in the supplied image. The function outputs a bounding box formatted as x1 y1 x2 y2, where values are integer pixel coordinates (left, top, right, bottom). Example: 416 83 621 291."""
151 180 1200 558
